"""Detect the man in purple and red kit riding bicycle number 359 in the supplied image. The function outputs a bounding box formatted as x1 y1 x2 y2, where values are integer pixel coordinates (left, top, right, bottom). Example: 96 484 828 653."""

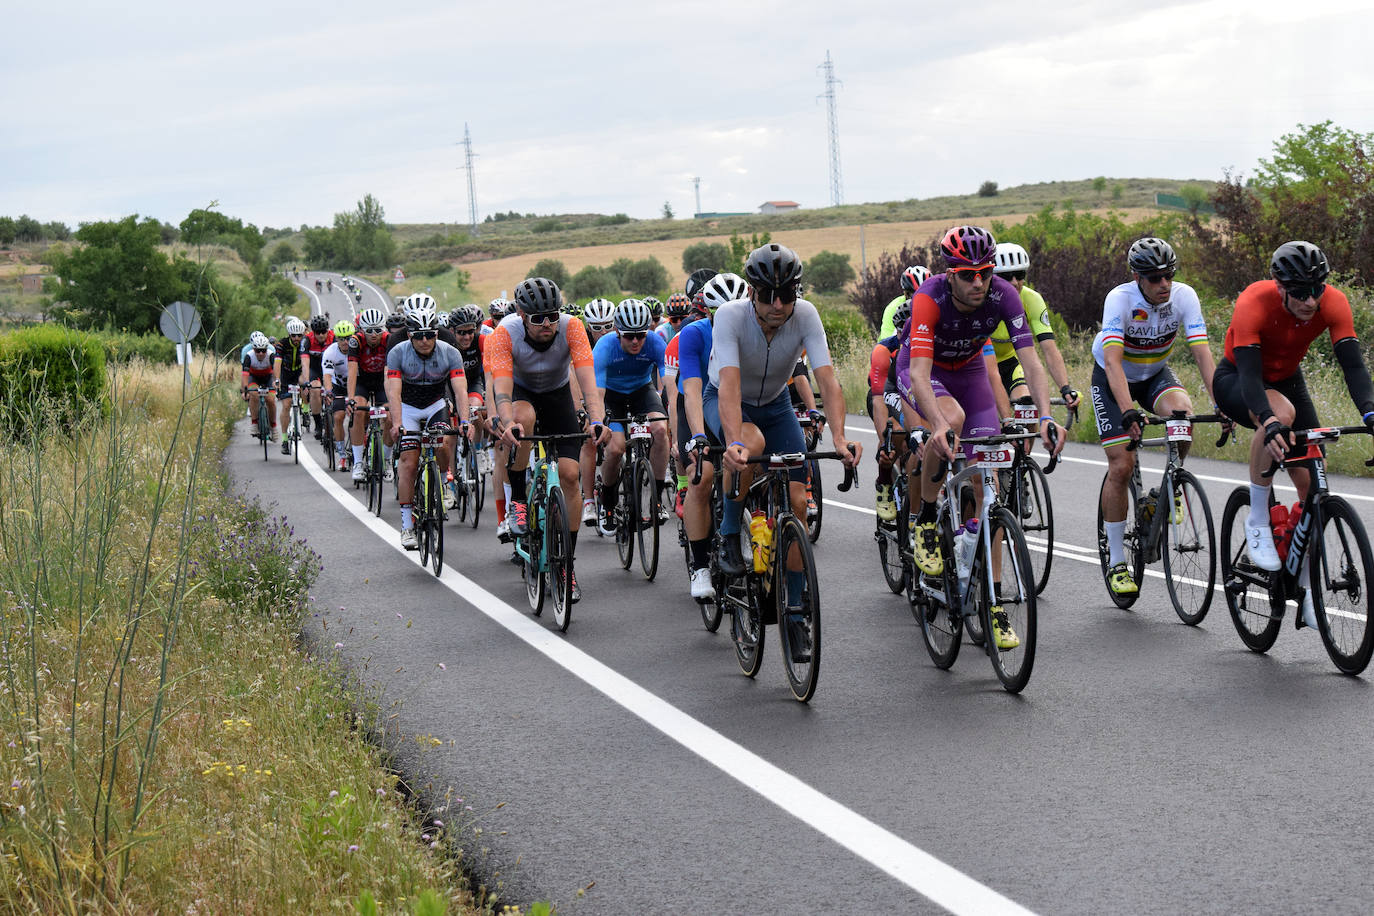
897 225 1063 650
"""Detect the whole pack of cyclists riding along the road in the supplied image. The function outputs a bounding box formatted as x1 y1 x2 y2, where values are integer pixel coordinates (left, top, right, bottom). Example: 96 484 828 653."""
243 233 1374 678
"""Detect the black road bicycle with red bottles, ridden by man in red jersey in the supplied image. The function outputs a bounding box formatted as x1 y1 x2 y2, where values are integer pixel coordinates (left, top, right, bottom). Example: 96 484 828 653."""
1221 426 1374 674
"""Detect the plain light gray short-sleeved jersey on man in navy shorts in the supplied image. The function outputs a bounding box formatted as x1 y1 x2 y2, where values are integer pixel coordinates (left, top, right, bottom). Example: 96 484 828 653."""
708 299 830 407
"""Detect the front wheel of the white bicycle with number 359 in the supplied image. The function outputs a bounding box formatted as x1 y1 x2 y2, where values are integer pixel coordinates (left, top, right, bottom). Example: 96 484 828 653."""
969 505 1036 694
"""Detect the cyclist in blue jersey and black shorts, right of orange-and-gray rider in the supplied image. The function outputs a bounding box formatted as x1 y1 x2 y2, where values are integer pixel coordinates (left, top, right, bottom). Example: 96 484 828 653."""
592 299 668 533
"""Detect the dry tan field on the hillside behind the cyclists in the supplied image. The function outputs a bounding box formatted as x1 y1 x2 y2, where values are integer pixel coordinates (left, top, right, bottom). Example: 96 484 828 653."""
460 207 1154 299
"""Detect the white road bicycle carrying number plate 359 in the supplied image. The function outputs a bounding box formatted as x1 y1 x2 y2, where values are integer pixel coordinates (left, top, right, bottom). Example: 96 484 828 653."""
908 430 1058 694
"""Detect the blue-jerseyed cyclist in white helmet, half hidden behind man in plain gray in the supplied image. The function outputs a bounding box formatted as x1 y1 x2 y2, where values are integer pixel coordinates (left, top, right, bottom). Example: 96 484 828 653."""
673 273 749 600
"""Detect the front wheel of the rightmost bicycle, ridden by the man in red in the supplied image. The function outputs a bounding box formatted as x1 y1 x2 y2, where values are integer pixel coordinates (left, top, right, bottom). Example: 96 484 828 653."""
1311 496 1374 674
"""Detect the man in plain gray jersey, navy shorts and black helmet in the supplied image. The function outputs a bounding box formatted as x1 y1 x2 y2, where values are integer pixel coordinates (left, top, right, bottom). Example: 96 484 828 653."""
708 243 863 587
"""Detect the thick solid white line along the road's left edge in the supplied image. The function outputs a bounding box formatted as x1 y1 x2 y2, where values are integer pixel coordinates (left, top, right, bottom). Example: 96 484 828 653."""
301 449 1031 913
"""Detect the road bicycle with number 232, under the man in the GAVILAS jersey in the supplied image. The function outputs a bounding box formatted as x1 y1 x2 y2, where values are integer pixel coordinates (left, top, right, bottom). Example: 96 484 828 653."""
1098 411 1231 626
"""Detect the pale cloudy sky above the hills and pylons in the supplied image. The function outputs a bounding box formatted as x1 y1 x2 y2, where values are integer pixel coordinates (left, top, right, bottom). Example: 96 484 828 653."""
0 0 1374 227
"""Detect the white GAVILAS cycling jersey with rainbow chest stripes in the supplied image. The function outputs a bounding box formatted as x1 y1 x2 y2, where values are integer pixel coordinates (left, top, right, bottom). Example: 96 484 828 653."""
1092 280 1206 382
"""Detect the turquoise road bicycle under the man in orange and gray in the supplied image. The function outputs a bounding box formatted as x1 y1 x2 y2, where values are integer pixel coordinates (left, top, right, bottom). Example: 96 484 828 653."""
506 433 587 633
